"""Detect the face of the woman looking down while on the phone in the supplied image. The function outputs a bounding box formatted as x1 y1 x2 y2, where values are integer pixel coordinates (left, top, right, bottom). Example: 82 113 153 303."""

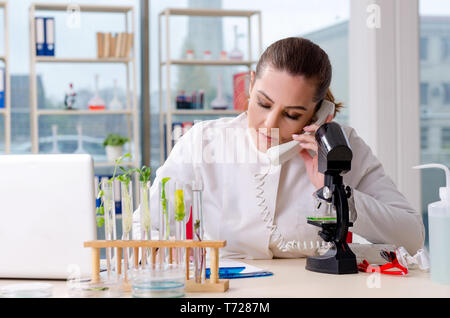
247 66 317 152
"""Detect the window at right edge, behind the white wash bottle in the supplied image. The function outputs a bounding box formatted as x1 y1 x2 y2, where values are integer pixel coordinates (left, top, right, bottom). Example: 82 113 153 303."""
419 0 450 248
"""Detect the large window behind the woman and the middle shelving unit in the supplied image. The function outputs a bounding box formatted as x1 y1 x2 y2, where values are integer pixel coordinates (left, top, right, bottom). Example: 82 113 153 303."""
150 0 350 171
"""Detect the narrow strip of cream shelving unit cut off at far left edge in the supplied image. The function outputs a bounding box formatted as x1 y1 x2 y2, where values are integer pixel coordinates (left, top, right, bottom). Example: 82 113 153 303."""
0 1 11 154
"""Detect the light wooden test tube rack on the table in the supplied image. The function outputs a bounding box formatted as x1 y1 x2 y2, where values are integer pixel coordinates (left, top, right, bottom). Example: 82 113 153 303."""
84 240 229 292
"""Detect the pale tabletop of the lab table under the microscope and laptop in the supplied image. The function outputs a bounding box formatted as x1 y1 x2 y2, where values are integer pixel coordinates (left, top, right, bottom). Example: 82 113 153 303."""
0 258 450 298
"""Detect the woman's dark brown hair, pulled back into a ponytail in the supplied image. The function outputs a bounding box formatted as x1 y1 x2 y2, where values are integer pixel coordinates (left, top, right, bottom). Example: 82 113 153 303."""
255 37 342 114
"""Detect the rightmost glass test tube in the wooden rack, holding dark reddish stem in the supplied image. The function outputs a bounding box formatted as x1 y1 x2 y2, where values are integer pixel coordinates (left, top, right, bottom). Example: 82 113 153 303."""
192 180 206 283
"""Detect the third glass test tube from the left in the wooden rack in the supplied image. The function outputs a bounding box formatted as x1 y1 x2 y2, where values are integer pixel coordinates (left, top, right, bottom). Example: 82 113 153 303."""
139 181 152 267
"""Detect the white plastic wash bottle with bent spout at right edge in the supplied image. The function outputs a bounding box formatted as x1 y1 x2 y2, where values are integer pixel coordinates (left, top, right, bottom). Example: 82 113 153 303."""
413 163 450 284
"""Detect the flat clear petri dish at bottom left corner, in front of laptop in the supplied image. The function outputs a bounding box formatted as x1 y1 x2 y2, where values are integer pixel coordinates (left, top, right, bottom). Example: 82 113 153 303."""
0 283 53 298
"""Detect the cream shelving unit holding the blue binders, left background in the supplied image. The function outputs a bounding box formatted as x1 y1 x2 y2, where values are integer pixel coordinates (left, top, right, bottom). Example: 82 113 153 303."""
29 3 140 167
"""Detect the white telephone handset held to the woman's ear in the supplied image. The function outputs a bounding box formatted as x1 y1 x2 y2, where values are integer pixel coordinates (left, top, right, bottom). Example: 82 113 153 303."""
266 99 335 166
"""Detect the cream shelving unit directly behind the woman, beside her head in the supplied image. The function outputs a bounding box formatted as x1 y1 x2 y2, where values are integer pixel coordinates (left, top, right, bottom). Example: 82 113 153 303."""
158 8 262 164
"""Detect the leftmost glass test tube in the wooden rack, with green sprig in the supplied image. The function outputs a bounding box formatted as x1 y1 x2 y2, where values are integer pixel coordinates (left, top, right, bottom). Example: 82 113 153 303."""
101 179 117 278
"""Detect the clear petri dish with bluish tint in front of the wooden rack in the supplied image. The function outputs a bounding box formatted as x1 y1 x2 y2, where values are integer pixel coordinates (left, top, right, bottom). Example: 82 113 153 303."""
131 264 186 298
